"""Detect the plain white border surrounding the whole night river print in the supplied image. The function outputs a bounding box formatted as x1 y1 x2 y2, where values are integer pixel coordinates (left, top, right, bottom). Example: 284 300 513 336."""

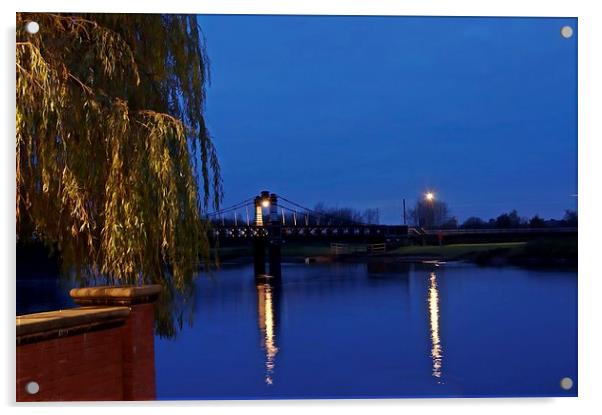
0 0 602 414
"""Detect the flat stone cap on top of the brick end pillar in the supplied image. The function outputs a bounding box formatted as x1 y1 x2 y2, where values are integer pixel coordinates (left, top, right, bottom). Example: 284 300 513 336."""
69 284 161 305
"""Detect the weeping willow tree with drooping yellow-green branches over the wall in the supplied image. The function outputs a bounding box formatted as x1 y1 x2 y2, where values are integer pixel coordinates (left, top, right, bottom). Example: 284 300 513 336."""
16 13 222 338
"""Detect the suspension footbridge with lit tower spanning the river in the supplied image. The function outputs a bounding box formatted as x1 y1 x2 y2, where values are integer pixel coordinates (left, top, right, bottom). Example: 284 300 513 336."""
207 191 577 278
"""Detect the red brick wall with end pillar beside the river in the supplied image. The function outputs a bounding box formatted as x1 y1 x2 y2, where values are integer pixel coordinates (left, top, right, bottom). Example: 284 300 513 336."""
16 291 161 402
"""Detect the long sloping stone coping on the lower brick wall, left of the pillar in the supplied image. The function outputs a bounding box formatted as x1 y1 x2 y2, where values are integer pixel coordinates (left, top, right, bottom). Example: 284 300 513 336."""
17 307 130 343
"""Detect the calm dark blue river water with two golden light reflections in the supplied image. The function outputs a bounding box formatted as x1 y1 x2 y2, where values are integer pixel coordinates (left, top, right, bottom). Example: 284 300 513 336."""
155 264 577 399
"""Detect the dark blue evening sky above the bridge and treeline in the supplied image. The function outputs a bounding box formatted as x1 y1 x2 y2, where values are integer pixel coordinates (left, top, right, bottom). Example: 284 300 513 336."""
198 15 577 223
